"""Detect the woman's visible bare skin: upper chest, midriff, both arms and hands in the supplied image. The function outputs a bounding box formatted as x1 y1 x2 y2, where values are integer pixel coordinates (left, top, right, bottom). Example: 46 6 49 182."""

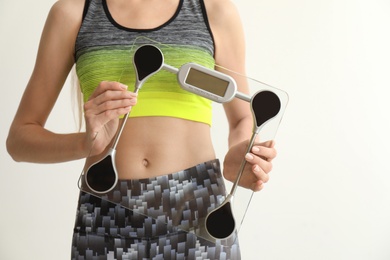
7 0 276 191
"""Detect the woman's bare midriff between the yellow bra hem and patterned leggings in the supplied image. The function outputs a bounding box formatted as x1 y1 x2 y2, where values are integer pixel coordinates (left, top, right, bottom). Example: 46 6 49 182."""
86 117 215 179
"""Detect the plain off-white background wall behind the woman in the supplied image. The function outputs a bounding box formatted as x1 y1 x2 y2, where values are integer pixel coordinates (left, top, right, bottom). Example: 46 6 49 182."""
0 0 390 260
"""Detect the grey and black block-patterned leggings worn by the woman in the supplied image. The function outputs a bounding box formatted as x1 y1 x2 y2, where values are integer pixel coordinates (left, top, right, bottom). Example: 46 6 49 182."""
72 160 241 260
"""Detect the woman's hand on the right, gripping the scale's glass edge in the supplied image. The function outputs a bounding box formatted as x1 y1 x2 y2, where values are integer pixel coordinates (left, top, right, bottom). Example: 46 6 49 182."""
223 140 276 191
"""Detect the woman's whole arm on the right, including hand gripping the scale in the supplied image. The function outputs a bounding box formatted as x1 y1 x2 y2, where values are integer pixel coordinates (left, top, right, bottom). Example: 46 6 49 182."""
205 0 276 191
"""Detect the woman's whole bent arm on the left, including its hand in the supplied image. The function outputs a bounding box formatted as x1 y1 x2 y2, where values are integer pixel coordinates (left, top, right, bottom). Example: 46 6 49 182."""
7 0 134 163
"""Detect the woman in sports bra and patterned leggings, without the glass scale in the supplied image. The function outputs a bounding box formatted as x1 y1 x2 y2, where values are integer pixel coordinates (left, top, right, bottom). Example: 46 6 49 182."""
7 0 276 259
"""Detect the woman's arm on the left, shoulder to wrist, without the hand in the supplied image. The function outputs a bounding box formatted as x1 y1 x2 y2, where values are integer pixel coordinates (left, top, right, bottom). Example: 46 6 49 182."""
7 1 86 163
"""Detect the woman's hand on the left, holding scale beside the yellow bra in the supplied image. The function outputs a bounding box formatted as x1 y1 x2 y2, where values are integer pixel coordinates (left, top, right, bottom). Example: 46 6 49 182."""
84 81 137 156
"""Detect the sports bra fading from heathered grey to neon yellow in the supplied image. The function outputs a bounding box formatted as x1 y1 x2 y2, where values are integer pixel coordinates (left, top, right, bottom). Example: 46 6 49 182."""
75 0 214 125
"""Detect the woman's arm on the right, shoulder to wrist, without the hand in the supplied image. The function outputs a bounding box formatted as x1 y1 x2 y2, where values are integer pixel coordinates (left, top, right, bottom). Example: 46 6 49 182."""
205 0 253 147
